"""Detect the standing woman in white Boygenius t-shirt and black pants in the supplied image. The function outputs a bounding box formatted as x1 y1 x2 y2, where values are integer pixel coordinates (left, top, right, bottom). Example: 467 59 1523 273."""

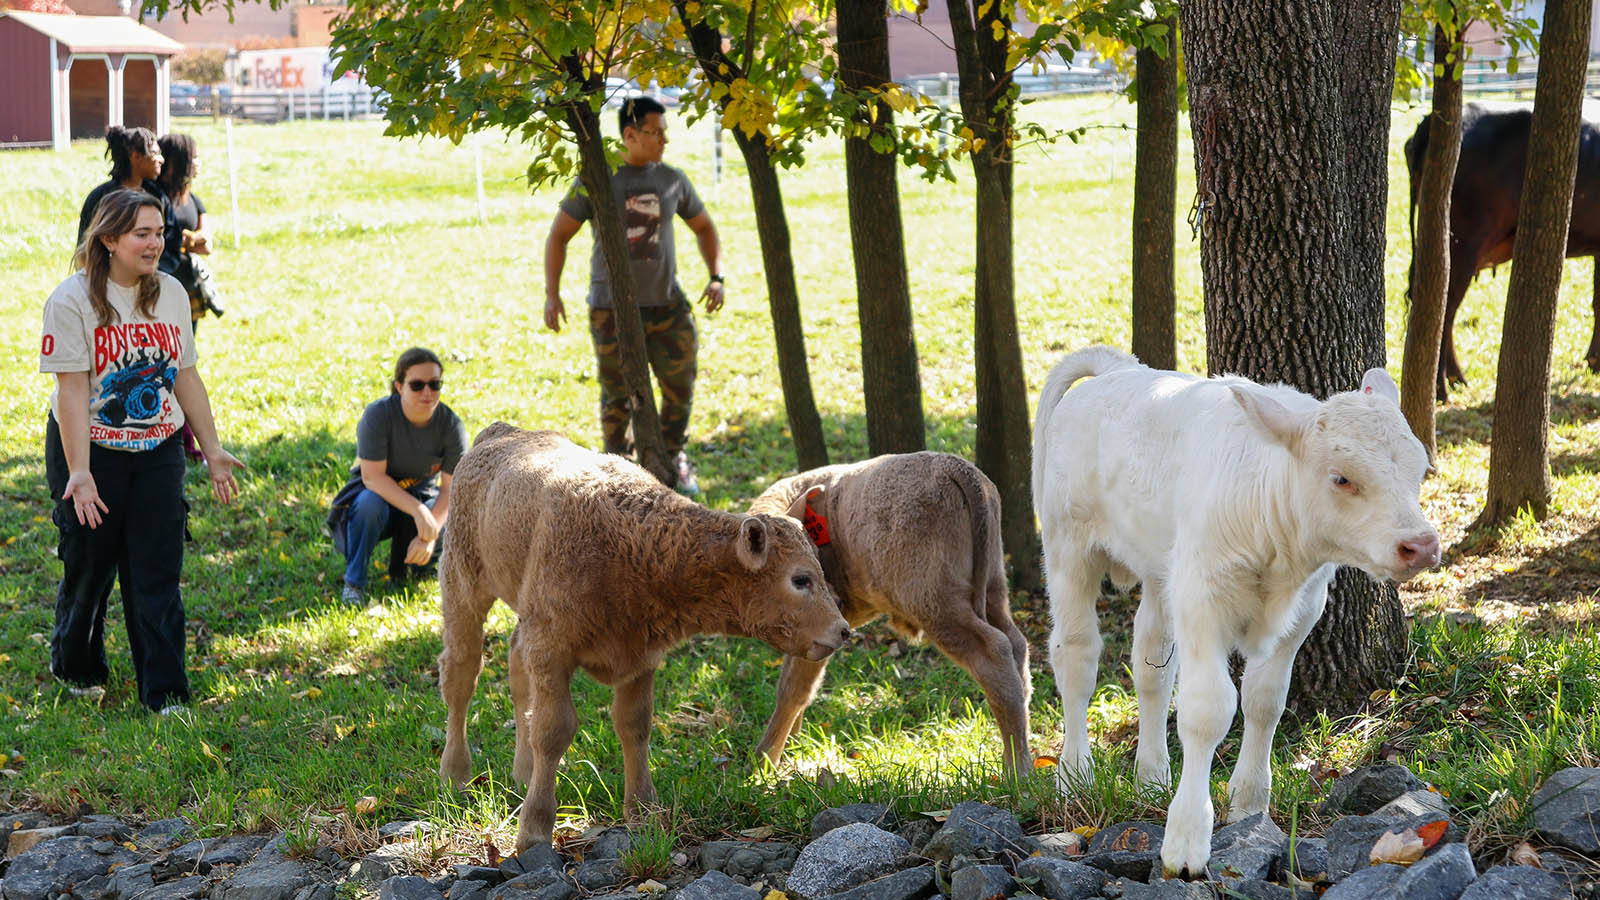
38 191 243 713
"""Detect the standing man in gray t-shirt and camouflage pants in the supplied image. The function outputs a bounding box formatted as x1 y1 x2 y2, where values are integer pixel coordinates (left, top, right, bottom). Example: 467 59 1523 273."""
544 98 723 495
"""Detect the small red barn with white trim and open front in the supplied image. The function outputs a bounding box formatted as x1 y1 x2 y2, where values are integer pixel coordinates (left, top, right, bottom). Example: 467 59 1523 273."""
0 10 182 151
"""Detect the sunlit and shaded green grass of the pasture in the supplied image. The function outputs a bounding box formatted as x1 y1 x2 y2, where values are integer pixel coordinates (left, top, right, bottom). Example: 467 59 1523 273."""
0 98 1600 865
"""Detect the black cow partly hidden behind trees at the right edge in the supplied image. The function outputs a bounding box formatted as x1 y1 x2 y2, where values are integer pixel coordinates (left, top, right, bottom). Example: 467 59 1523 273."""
1405 102 1600 400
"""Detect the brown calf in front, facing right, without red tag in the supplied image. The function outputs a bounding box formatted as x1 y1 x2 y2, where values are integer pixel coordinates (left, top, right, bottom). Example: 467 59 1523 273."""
438 423 850 852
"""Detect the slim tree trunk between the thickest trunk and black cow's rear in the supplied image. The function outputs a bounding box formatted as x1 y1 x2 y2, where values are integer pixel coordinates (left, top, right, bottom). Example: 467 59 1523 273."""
1400 26 1462 460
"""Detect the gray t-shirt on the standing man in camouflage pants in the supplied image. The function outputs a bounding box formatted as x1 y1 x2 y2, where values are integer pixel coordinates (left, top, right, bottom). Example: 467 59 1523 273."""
562 162 706 309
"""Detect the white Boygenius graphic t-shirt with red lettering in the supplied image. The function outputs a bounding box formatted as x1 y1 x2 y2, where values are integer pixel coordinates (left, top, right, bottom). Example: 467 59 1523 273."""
38 271 195 450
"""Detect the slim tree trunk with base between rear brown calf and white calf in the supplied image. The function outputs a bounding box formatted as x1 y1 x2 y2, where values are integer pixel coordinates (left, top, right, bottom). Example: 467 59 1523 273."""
949 0 1043 591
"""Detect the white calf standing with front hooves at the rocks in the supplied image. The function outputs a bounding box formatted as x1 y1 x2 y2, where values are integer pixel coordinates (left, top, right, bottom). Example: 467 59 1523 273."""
1034 348 1438 878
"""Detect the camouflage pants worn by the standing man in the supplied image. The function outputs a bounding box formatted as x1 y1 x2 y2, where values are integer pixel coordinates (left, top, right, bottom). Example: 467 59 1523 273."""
589 299 699 455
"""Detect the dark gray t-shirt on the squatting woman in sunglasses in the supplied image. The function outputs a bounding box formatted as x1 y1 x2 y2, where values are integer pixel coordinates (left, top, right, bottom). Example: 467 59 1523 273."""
350 394 467 498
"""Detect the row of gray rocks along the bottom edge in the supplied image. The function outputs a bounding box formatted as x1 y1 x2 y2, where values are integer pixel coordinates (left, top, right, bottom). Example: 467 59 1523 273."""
0 765 1600 900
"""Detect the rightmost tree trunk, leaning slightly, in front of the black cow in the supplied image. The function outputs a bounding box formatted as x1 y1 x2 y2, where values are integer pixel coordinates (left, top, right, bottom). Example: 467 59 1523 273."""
1478 0 1590 524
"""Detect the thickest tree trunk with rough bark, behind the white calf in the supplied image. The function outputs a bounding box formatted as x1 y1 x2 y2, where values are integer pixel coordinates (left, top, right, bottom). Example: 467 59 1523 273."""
1179 0 1405 711
